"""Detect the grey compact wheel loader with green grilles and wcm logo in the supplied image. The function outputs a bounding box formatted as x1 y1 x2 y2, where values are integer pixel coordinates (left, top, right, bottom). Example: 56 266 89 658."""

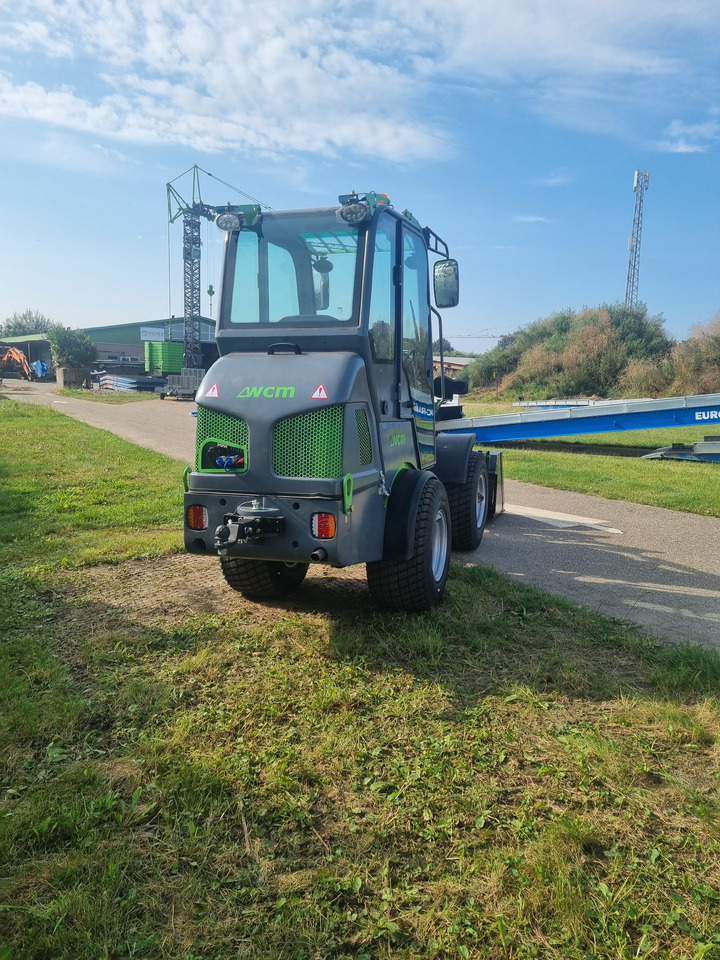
185 193 502 611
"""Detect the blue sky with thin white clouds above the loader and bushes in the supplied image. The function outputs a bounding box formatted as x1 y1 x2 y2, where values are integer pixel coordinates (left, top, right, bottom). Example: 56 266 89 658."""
0 0 720 352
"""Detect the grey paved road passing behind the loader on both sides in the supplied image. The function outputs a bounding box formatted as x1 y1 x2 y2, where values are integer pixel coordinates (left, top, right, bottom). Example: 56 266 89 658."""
5 380 720 650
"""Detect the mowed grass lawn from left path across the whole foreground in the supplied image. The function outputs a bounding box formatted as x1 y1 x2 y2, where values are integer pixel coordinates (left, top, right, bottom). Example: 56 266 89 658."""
0 404 720 960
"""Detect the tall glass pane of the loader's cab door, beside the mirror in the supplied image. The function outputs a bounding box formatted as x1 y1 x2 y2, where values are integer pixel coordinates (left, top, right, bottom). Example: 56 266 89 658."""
402 230 432 400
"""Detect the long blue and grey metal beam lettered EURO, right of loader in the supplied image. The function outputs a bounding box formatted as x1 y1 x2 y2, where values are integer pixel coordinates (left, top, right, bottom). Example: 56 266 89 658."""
438 393 720 444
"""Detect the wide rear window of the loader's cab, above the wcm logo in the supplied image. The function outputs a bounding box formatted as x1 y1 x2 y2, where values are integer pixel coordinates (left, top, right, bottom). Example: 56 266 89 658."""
221 210 358 327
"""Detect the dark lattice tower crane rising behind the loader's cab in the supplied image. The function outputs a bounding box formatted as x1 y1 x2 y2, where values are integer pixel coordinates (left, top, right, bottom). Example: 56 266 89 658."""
166 164 272 369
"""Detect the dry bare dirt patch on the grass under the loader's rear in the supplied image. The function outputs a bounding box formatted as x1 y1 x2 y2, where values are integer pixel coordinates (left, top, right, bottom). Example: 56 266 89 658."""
62 554 370 627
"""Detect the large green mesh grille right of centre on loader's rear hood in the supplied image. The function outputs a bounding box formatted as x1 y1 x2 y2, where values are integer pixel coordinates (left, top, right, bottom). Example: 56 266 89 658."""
273 406 344 480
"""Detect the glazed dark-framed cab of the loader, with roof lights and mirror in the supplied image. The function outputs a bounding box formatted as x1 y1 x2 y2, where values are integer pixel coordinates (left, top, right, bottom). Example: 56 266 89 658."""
216 194 457 467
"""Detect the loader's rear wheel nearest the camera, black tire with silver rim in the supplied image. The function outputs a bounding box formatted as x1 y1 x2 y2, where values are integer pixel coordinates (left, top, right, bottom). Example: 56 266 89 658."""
365 477 452 612
